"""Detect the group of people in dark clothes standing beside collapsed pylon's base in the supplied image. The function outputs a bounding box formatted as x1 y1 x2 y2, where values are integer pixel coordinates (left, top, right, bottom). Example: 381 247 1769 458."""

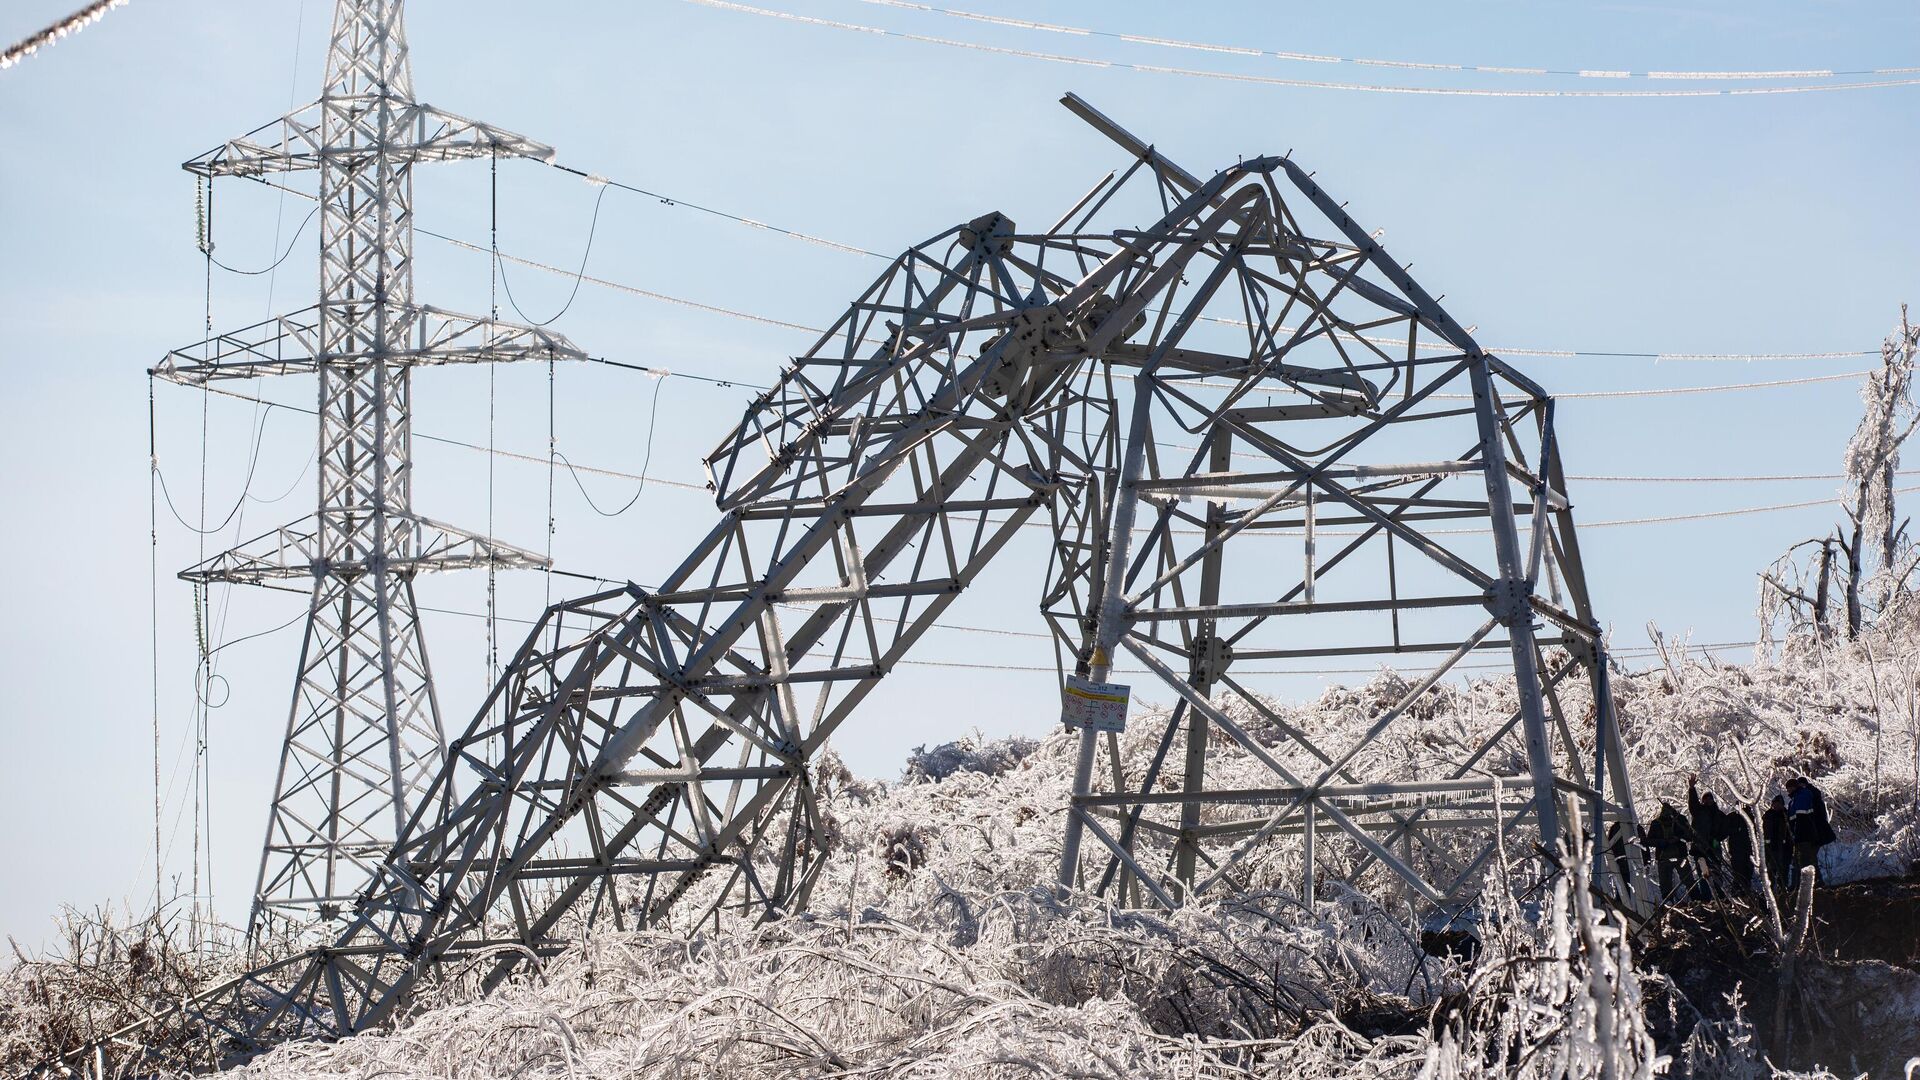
1644 776 1834 899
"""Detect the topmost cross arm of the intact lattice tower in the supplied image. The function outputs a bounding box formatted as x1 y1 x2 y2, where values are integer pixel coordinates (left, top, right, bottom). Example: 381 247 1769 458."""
180 94 553 177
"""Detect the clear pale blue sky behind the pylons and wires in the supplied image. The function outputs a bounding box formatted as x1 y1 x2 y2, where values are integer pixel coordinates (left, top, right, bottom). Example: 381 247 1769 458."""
0 0 1920 942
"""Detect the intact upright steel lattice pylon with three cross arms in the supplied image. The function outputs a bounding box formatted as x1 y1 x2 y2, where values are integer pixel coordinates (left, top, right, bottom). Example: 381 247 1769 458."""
156 0 582 932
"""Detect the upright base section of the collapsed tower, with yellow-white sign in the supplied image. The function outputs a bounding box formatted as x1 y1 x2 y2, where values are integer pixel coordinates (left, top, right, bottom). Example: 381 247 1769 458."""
1043 100 1634 907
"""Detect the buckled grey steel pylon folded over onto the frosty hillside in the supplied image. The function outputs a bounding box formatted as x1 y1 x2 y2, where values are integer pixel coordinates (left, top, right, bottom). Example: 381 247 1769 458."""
93 96 1634 1055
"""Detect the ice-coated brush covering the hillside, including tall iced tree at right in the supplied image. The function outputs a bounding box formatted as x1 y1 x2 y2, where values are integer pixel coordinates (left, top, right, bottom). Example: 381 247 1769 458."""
15 307 1920 1080
